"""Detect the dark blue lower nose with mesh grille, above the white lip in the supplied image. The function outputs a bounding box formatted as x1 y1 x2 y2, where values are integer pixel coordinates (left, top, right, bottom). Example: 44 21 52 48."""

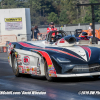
57 64 100 75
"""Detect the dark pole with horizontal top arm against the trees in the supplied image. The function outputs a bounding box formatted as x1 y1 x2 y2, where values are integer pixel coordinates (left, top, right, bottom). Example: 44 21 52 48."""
77 3 100 44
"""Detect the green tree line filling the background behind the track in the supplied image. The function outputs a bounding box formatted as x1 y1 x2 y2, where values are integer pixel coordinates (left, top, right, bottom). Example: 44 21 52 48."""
0 0 100 25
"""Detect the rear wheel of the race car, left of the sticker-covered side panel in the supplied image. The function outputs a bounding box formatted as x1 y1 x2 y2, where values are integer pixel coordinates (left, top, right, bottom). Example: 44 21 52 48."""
12 53 21 77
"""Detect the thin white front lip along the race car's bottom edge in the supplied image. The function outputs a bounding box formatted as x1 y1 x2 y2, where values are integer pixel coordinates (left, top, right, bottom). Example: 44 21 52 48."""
56 72 100 77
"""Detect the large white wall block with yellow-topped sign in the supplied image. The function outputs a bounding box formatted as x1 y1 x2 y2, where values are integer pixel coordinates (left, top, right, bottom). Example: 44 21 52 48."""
0 8 31 40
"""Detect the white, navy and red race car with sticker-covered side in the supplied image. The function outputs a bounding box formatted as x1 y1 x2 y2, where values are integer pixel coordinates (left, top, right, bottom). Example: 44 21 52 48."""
8 31 100 81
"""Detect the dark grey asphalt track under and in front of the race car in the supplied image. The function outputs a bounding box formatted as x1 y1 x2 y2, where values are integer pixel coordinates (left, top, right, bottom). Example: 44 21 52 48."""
0 53 100 100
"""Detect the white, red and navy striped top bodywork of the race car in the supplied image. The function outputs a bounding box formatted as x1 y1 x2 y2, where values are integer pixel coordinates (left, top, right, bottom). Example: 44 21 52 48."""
19 41 100 62
